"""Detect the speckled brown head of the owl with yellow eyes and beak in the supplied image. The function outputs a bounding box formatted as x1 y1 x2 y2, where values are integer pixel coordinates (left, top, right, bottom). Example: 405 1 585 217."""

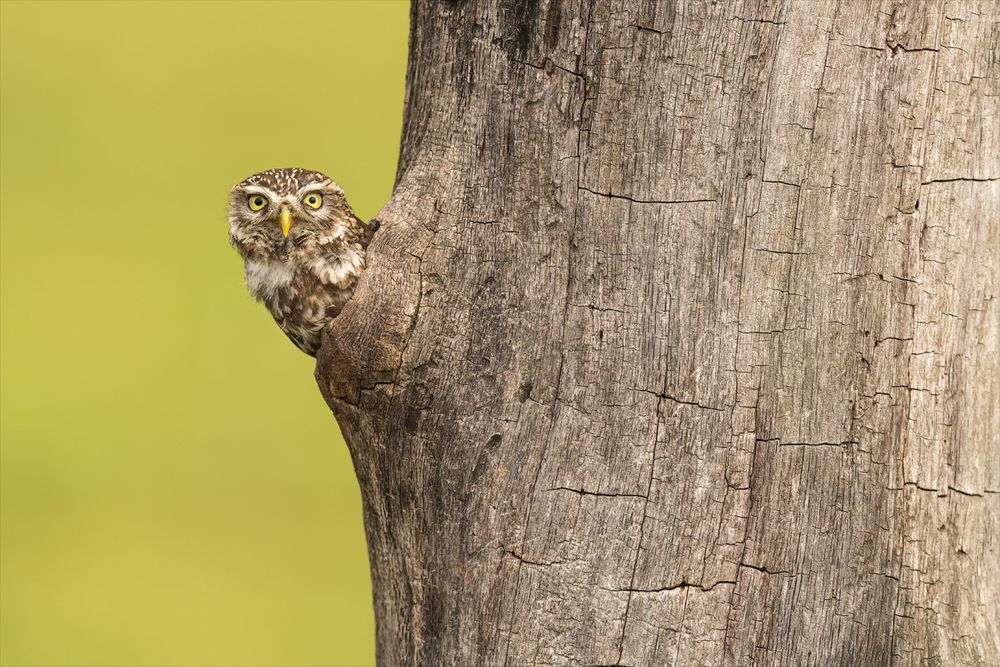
229 168 354 259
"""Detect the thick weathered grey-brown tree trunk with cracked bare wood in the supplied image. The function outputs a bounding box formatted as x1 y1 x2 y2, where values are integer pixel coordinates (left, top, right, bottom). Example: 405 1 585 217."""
317 0 1000 665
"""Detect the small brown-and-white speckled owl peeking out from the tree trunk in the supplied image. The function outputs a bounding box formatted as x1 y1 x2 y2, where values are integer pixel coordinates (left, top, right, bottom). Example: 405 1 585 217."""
229 169 377 356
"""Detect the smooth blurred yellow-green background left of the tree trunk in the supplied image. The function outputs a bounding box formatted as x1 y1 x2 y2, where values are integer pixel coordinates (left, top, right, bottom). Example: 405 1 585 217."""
0 0 408 667
